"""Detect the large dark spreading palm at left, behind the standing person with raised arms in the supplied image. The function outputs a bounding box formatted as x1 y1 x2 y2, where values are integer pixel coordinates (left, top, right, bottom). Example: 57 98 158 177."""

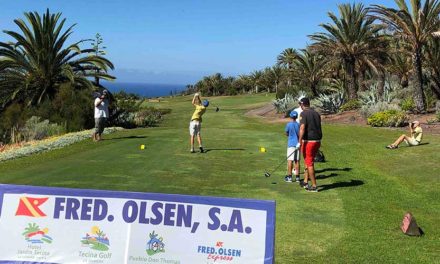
0 10 114 105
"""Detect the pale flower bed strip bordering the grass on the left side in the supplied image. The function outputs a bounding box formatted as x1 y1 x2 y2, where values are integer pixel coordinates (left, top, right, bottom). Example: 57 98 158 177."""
0 127 123 161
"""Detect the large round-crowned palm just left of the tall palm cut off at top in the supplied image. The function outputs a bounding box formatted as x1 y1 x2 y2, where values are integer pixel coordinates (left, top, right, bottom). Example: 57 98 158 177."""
310 4 384 99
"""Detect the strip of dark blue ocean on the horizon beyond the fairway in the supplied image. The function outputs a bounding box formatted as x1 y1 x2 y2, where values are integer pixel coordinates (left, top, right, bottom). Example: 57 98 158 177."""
102 82 185 98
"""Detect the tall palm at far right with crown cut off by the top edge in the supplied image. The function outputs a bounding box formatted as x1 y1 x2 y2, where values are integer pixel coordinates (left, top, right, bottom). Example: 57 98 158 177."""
370 0 440 113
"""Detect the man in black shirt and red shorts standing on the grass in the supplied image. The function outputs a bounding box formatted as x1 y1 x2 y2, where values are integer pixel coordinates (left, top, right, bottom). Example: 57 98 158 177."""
299 97 322 192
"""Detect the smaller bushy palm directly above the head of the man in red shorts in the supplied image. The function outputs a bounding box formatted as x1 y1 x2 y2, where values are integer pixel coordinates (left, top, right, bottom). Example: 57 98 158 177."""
294 49 327 96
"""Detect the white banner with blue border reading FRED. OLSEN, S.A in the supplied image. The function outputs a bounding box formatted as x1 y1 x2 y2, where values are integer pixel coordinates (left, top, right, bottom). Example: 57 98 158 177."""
0 184 275 264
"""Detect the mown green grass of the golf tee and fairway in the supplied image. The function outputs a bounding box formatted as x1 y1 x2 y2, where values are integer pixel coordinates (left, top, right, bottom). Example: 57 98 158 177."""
0 95 440 264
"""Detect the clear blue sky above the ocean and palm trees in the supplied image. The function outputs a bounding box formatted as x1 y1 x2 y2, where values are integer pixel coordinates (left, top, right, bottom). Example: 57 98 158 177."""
0 0 395 84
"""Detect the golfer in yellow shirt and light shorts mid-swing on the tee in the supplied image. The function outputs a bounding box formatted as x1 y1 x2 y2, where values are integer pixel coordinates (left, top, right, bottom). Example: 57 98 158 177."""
189 93 209 153
